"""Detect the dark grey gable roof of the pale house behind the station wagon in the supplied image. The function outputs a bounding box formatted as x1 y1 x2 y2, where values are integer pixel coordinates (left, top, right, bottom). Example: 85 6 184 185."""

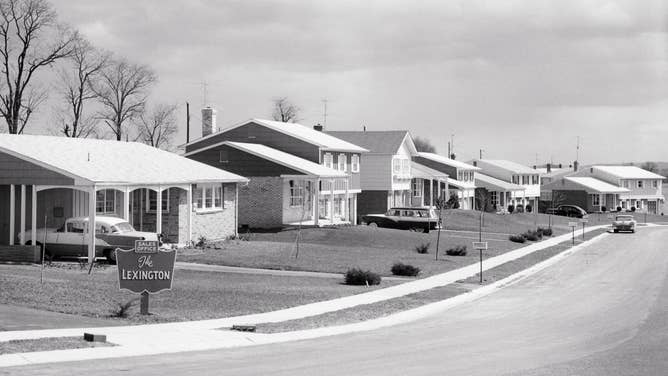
327 131 417 155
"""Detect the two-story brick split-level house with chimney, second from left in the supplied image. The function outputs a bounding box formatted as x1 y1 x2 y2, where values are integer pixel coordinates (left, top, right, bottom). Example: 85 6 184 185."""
185 113 367 228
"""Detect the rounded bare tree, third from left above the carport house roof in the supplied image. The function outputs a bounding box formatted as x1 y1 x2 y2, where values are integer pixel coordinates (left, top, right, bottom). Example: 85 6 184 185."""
92 59 157 141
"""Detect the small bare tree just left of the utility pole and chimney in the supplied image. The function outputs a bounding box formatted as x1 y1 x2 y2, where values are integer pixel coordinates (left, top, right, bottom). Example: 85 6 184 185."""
139 104 178 149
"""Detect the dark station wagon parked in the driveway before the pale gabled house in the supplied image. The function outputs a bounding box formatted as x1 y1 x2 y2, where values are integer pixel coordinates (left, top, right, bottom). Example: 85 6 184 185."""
362 208 438 232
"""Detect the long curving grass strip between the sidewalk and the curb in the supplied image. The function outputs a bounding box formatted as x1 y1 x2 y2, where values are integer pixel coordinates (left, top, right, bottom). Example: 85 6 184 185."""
257 230 605 333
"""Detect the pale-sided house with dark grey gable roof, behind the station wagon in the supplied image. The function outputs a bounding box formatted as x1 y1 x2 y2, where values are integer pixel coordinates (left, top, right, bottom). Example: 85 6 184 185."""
327 130 447 216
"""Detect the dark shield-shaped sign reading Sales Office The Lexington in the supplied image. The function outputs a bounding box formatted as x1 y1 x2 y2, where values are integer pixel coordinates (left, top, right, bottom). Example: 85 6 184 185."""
116 240 176 294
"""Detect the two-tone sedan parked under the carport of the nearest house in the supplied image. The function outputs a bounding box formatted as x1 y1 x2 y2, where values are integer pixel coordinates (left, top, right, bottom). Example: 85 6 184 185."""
19 216 158 264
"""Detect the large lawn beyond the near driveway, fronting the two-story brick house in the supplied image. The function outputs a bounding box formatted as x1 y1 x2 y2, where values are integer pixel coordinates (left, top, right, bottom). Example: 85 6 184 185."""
178 210 592 277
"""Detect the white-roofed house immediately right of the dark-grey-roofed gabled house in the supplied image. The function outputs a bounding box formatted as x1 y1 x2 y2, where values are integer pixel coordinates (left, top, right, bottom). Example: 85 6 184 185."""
413 152 480 209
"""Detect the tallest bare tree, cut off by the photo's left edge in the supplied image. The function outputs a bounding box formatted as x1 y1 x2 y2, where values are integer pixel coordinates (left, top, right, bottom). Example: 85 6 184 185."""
0 0 78 134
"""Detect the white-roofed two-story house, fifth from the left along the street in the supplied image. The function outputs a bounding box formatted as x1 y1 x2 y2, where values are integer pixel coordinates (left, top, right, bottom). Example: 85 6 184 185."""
470 159 540 211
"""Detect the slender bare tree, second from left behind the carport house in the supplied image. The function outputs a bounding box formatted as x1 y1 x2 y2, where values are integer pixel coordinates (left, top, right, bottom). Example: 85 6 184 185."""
59 39 109 138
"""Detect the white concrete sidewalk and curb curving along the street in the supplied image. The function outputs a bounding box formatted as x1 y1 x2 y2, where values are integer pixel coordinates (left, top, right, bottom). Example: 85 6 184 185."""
0 226 606 367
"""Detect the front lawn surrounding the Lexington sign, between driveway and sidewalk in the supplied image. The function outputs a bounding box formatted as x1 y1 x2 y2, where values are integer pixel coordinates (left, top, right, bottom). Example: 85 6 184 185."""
0 264 396 324
